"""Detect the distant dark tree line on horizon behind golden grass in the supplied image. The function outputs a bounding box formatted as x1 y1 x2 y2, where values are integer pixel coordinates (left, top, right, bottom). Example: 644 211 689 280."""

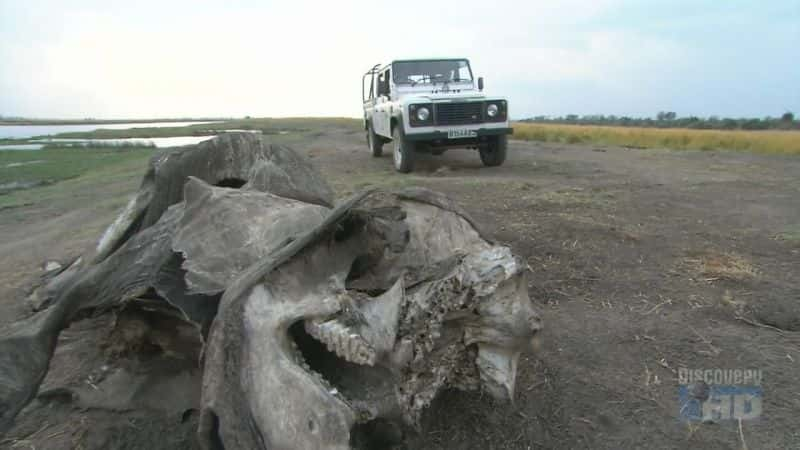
520 111 800 130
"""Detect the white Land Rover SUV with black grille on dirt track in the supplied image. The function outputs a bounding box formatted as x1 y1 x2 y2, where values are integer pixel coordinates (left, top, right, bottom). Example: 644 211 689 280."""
362 58 513 172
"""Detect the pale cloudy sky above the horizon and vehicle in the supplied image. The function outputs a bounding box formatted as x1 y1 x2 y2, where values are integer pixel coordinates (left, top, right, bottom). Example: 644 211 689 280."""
0 0 800 118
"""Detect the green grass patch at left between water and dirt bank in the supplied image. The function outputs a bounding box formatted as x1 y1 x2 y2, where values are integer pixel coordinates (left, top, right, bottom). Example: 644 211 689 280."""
0 147 154 200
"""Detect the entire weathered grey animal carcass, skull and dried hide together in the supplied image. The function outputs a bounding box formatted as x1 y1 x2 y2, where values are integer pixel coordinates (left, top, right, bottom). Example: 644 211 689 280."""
0 135 540 449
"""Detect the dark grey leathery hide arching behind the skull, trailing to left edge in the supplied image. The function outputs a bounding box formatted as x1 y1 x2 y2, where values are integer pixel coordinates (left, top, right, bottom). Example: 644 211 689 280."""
0 133 333 432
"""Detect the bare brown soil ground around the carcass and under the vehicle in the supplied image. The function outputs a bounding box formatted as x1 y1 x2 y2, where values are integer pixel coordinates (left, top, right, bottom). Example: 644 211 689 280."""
0 129 800 449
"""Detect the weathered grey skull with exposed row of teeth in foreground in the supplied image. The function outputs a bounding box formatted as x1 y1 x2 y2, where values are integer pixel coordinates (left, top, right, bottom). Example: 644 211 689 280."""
201 190 539 449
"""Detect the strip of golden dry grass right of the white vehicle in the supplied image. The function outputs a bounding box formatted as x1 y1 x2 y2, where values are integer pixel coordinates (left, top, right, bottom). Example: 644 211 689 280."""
513 123 800 155
